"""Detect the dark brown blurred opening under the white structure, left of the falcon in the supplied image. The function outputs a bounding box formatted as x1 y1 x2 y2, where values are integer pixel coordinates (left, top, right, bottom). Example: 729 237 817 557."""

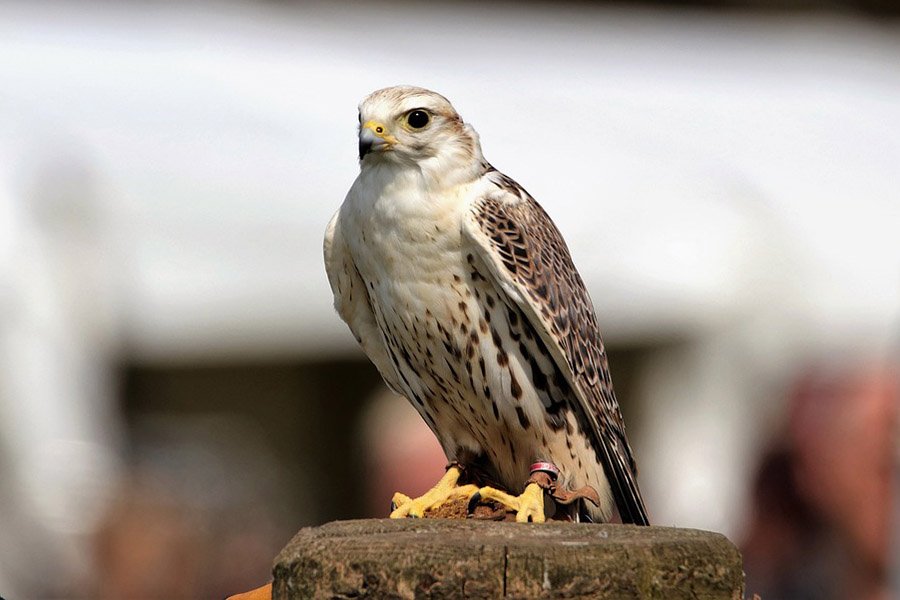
87 361 380 600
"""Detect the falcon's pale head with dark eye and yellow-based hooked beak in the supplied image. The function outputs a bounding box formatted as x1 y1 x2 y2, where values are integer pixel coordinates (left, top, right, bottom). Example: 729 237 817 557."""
359 86 481 175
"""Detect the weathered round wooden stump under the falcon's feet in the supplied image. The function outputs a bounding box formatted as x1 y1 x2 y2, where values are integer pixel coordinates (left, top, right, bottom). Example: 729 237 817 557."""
272 519 744 600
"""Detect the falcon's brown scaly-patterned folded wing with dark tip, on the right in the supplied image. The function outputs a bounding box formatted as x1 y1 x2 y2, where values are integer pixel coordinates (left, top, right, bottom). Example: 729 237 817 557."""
463 171 649 525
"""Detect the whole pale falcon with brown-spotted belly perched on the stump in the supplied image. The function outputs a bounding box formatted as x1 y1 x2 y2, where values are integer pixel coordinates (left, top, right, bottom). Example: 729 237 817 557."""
324 86 648 525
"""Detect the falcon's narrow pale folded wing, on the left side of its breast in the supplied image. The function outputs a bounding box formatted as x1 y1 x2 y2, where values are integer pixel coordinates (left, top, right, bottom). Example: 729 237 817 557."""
324 211 401 394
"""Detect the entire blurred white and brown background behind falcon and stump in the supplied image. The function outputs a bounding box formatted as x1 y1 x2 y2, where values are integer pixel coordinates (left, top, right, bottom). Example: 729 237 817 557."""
0 0 900 599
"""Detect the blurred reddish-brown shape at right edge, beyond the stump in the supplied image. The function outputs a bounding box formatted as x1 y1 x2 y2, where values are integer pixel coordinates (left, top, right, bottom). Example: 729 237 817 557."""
742 363 900 600
